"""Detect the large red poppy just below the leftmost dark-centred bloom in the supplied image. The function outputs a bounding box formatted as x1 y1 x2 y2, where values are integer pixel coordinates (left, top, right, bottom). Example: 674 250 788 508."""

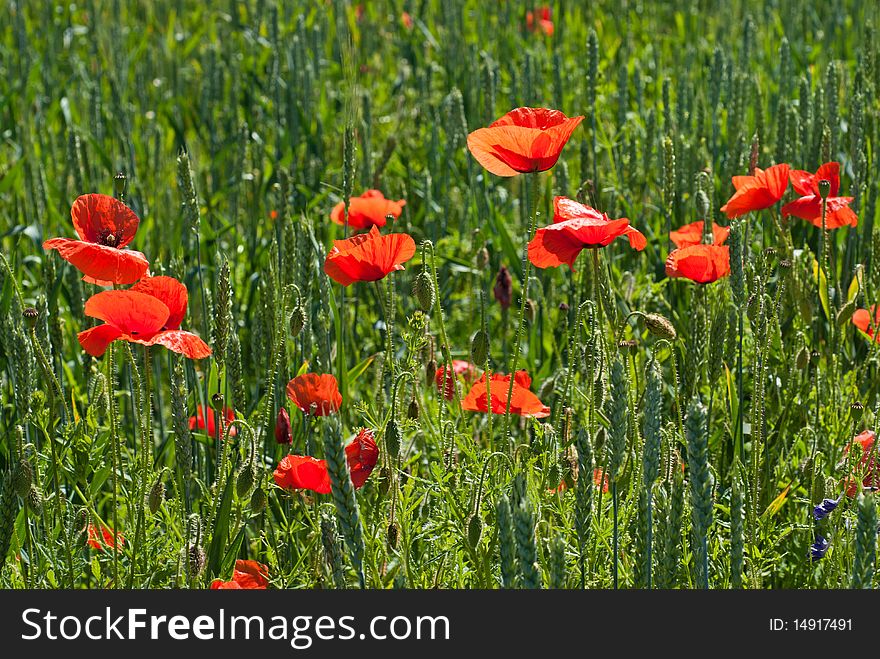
77 277 211 359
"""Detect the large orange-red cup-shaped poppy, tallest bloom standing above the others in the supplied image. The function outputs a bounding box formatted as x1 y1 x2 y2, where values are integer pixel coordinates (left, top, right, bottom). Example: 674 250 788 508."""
468 108 584 176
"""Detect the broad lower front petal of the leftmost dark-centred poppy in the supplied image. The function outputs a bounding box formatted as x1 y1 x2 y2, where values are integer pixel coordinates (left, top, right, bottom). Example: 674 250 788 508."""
43 238 150 285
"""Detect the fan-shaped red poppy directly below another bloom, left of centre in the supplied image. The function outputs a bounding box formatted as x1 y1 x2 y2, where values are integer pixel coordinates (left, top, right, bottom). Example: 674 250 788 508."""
324 226 416 286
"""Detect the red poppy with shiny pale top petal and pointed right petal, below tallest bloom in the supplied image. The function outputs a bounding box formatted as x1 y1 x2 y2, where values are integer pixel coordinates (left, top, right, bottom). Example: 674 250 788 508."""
529 197 648 270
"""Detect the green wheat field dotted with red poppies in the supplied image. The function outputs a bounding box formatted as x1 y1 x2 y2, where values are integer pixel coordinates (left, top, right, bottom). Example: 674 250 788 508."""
0 0 880 589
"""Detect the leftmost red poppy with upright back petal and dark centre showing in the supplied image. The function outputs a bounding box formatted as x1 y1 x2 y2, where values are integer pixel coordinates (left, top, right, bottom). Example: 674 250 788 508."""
43 194 150 286
